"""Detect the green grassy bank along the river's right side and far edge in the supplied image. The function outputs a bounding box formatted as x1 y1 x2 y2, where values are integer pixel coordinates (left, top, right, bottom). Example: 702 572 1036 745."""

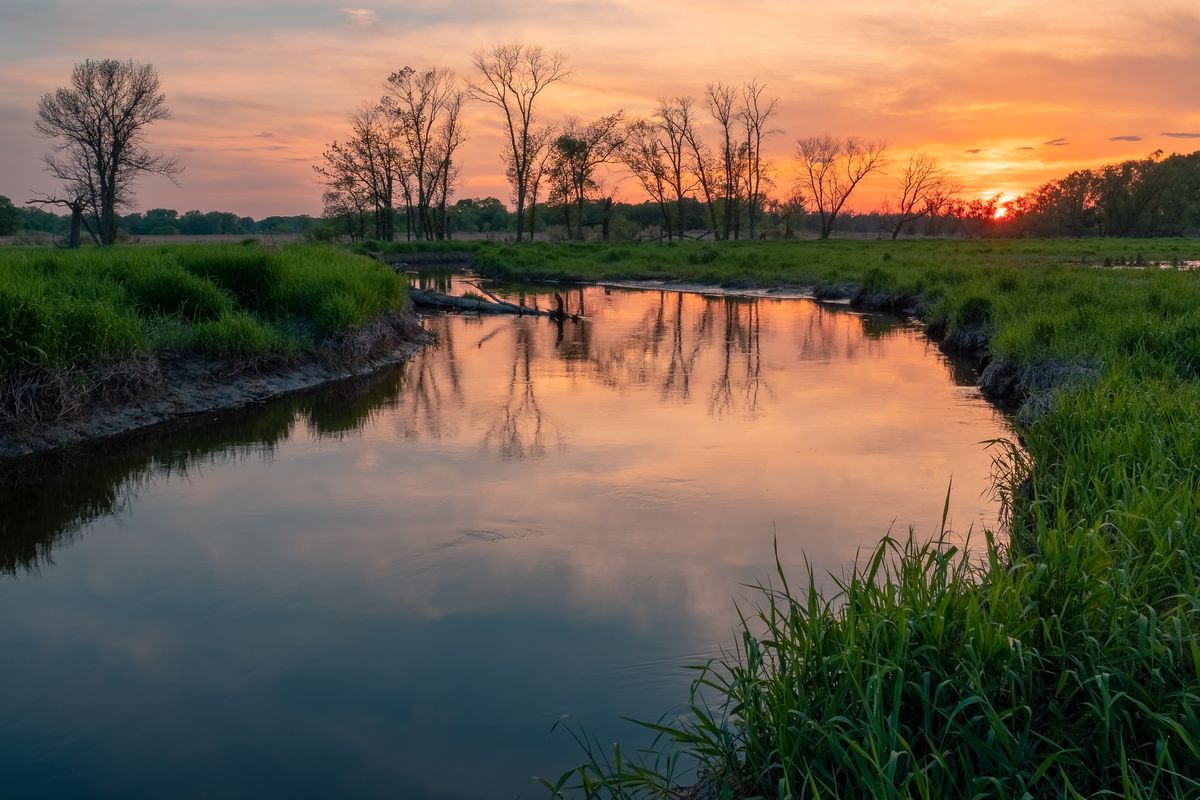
436 240 1200 798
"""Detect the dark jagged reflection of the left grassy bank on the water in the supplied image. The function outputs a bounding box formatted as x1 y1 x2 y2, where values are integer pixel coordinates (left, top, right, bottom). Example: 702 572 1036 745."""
0 367 401 575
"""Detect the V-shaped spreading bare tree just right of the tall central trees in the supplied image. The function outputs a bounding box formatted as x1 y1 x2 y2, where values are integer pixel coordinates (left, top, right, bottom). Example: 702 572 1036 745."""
796 133 887 239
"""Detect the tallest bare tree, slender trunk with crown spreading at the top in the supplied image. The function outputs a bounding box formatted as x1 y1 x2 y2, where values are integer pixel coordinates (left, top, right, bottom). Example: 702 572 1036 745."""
470 42 568 241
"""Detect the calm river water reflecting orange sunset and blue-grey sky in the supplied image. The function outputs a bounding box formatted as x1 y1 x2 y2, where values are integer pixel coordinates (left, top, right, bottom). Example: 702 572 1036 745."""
0 278 1009 799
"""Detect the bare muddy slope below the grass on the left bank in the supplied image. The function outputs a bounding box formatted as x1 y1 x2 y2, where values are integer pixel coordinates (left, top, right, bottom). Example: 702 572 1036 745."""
0 311 433 464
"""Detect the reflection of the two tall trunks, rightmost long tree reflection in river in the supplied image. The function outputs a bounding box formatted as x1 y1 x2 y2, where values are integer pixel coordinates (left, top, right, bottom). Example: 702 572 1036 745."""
708 297 773 416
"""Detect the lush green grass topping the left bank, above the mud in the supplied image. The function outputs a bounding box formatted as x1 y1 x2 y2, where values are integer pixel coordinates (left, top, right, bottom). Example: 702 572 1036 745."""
0 245 407 375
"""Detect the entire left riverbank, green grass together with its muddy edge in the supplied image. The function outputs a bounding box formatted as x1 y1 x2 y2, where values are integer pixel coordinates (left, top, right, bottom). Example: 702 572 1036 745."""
0 243 427 458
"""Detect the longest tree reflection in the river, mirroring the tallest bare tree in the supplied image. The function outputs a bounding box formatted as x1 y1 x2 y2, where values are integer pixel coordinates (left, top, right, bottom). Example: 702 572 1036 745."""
484 319 560 461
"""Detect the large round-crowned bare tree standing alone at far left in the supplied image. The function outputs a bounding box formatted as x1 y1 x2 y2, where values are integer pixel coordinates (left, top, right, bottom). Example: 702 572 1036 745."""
35 59 182 245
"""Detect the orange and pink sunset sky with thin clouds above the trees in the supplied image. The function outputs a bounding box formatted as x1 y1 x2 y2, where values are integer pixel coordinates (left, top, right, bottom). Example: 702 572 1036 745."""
0 0 1200 218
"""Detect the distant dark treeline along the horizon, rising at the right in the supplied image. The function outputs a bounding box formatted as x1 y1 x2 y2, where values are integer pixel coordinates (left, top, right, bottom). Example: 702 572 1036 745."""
0 151 1200 242
